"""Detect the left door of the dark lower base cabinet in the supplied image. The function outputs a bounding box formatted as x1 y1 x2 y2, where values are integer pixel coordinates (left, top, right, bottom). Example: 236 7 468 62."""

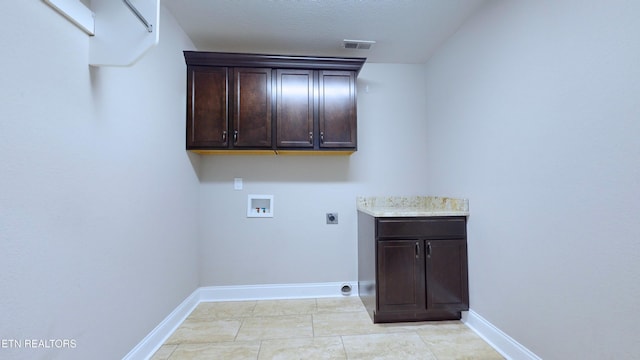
376 240 425 313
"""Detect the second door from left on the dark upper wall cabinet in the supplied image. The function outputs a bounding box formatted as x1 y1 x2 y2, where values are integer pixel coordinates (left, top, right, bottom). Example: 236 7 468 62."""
233 68 272 148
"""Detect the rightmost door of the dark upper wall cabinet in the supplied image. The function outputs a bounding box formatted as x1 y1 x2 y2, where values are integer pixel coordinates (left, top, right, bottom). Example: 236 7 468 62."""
318 71 357 148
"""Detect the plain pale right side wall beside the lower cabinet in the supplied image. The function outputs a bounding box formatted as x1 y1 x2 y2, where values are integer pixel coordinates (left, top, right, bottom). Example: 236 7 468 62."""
426 0 640 359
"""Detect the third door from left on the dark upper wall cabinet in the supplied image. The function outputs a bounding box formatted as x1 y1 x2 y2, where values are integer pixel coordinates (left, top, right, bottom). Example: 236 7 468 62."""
276 69 314 148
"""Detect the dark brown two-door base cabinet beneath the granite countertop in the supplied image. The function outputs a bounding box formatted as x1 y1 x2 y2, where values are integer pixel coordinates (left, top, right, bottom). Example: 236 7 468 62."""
358 213 469 323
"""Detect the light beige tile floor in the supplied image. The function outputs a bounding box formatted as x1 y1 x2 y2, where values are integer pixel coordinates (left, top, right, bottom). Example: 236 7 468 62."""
152 296 503 360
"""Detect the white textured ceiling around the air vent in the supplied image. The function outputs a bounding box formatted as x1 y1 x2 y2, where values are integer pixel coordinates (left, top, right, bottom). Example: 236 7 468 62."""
162 0 486 63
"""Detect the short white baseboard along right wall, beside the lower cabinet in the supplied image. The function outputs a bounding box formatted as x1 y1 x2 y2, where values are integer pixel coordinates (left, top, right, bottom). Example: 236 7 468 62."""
462 310 542 360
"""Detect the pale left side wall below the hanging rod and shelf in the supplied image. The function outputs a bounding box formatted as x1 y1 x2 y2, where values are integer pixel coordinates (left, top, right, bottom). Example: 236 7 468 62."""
0 1 199 359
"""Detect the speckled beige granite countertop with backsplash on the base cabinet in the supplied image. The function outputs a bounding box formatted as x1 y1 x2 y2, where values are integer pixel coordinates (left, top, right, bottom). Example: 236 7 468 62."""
356 196 469 217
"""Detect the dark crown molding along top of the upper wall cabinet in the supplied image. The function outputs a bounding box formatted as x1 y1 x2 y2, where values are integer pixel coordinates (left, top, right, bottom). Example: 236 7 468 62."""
183 50 367 74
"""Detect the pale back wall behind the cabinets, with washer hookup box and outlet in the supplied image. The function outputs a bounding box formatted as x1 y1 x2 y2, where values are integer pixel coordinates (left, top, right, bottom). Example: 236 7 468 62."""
200 64 426 286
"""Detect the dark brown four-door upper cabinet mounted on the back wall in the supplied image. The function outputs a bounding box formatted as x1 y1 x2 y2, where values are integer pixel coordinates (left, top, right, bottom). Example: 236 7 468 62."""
184 51 366 153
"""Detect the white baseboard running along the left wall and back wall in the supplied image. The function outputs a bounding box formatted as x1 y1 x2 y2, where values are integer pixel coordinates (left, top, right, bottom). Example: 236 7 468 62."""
123 281 358 360
